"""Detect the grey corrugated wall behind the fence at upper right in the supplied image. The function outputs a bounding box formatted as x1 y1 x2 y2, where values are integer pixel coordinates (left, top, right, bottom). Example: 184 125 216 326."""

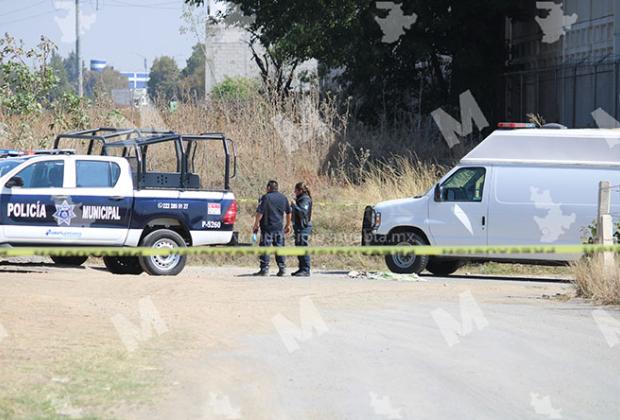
504 0 620 128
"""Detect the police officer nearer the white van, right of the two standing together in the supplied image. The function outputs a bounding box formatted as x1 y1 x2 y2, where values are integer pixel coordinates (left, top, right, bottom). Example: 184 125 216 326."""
291 182 312 277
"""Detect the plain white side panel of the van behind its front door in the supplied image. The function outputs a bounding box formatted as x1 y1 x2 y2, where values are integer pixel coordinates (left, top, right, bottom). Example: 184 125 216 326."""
489 165 620 260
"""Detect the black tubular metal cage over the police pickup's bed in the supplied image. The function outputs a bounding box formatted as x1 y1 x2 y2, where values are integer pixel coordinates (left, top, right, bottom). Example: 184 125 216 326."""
54 128 237 191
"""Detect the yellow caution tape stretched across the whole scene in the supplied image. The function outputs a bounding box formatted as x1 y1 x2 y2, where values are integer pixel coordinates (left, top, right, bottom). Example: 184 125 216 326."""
0 245 620 257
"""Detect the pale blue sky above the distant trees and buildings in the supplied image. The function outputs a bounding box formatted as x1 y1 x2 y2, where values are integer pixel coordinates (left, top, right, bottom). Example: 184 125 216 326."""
0 0 226 71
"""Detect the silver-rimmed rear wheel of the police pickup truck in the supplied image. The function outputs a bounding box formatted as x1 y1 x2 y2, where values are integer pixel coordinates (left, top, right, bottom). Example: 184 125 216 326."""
139 229 187 276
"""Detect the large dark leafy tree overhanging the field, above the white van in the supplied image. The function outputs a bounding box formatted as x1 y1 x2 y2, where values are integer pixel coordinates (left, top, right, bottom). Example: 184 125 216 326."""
186 0 519 122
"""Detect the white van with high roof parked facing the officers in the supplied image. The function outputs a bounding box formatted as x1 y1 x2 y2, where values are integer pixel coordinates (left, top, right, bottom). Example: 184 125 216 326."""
362 124 620 275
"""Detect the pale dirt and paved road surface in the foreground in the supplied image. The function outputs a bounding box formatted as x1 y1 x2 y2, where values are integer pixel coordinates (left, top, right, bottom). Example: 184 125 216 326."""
0 264 620 419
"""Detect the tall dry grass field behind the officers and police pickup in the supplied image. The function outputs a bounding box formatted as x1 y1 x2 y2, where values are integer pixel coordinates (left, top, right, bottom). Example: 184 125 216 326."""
0 96 600 275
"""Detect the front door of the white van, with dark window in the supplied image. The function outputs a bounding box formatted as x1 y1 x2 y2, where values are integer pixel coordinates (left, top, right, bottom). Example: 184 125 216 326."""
428 167 492 246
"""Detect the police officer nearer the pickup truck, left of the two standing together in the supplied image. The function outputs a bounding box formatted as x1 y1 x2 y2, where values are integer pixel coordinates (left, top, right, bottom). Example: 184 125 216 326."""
253 181 291 277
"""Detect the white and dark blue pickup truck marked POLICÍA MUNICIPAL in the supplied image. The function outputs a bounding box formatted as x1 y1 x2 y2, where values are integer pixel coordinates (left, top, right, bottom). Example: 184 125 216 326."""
0 130 237 275
